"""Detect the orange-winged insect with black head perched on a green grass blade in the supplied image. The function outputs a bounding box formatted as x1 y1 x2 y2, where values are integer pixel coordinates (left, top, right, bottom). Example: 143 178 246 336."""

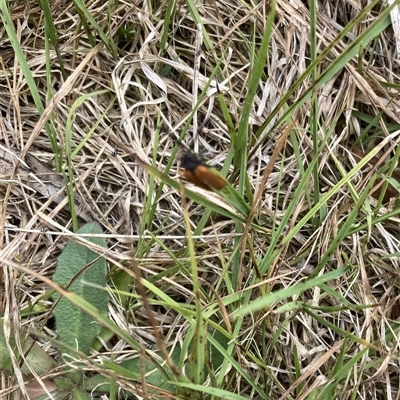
181 152 227 190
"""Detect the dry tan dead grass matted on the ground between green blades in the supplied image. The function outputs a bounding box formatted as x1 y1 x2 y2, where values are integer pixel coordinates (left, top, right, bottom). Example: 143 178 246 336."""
0 1 400 399
